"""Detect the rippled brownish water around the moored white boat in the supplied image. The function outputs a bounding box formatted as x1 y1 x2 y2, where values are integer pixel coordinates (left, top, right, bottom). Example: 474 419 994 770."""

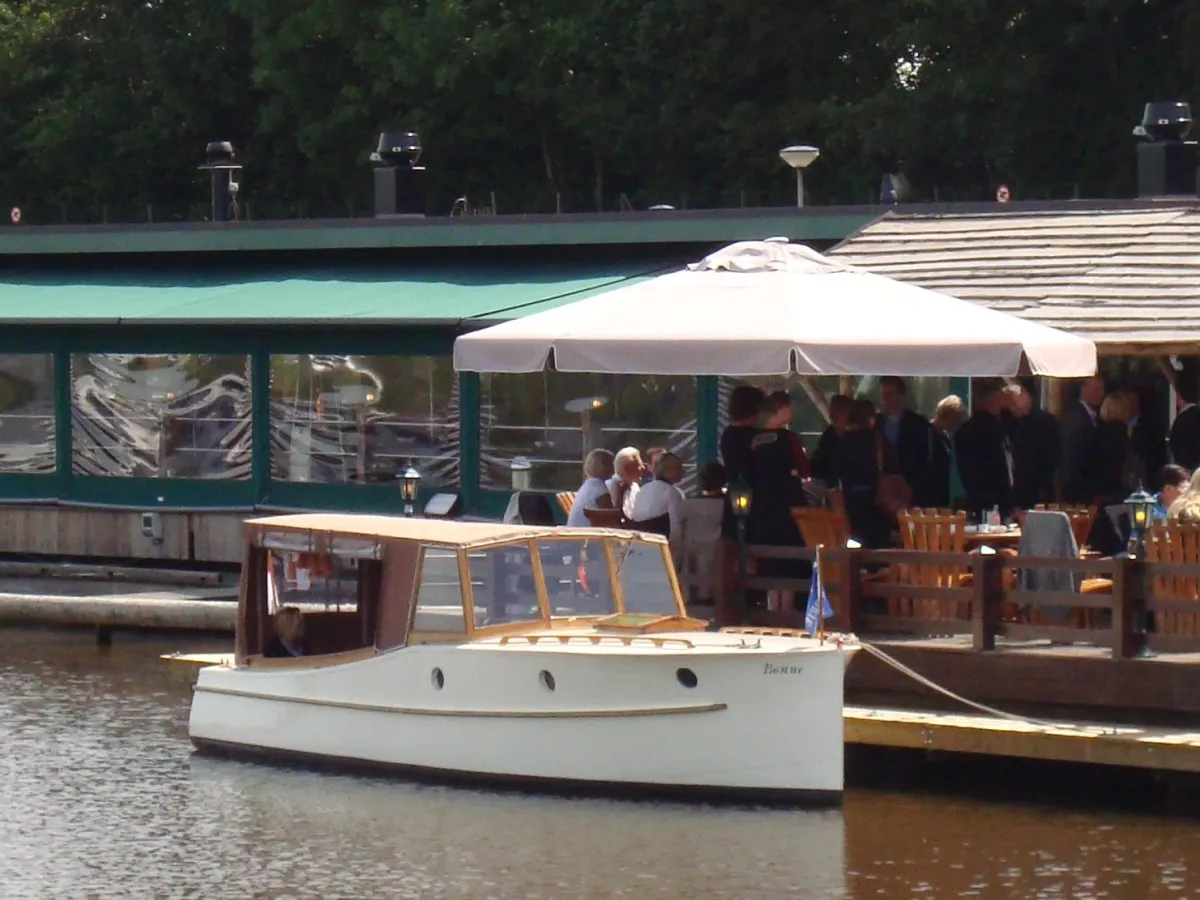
0 631 1200 900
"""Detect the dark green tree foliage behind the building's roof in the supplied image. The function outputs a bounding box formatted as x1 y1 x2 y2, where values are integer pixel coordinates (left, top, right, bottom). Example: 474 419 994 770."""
0 0 1200 221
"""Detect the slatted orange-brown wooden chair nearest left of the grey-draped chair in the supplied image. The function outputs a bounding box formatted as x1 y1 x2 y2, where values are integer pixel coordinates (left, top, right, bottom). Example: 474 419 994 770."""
888 509 971 619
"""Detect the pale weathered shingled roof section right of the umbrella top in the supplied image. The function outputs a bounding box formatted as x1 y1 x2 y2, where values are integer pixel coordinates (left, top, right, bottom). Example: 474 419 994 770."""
829 203 1200 353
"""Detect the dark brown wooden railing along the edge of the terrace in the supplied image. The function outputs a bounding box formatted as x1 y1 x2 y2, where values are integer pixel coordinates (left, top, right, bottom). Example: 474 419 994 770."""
680 545 1200 659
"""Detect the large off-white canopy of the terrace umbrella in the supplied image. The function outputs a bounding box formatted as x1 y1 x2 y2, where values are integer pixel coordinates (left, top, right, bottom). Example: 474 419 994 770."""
454 239 1096 378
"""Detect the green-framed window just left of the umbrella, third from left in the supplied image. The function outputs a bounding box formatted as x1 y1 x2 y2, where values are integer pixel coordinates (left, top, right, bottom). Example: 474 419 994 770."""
271 354 458 486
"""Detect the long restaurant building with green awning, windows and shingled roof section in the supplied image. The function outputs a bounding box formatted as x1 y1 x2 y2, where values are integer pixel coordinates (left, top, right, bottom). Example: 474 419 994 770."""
0 200 1200 562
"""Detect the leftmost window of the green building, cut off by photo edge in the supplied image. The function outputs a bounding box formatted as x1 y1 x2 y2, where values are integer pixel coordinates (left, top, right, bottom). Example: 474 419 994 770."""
0 353 54 474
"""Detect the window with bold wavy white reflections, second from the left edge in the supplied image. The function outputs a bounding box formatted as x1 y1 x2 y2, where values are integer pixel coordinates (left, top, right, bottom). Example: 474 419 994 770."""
71 353 251 479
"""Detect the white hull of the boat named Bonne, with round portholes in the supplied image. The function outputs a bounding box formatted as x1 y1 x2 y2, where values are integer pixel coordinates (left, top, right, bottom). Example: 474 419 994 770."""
190 635 846 803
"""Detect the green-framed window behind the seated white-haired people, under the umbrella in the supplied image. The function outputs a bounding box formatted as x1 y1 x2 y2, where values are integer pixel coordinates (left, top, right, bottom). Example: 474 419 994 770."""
480 372 696 491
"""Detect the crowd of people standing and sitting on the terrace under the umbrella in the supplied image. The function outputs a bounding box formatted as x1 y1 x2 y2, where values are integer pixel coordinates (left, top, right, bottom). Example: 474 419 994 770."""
568 376 1200 577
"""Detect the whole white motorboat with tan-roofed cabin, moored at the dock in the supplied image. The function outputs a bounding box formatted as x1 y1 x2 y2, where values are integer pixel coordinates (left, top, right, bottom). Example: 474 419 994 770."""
190 515 854 803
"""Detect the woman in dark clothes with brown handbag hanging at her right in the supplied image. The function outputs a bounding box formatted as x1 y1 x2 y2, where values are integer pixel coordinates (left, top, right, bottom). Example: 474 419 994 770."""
833 400 900 550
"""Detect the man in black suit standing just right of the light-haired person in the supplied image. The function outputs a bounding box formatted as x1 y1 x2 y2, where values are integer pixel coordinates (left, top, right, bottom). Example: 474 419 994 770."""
954 379 1014 516
